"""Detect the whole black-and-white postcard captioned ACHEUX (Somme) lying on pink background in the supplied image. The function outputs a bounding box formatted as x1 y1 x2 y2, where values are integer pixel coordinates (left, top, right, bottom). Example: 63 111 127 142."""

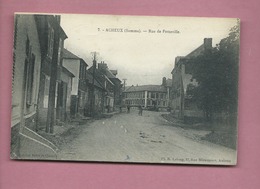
10 13 240 165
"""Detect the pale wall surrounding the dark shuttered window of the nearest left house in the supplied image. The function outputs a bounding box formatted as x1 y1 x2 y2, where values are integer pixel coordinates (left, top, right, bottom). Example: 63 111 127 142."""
12 15 41 126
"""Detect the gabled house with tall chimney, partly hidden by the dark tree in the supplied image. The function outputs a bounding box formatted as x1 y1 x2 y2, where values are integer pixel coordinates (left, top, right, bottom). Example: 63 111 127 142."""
171 38 212 119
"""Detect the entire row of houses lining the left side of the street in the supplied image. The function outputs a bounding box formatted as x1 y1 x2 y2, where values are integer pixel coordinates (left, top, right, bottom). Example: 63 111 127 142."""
11 14 122 158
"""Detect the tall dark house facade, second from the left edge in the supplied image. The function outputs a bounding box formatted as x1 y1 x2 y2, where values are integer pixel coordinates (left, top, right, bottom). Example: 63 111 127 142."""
36 15 67 132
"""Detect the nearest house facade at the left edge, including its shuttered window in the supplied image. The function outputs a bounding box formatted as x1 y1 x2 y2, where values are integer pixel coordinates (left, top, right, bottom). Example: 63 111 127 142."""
12 15 41 129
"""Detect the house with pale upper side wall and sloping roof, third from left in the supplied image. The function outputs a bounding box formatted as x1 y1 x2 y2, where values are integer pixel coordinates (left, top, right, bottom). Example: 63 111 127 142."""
62 49 89 117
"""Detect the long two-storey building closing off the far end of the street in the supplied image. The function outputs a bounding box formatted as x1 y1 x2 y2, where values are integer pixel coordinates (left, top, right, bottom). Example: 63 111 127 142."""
123 78 171 110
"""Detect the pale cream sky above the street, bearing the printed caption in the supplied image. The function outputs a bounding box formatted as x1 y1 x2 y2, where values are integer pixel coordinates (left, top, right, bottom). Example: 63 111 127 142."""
61 14 237 86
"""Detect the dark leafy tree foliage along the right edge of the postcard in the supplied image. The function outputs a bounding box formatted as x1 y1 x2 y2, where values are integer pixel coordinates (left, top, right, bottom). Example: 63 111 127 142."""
188 22 239 118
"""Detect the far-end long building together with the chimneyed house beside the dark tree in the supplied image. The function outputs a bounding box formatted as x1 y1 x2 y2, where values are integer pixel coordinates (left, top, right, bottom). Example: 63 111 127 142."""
123 38 212 119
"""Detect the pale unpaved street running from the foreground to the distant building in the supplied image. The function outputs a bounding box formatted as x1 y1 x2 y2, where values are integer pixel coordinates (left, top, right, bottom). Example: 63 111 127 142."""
58 110 236 164
